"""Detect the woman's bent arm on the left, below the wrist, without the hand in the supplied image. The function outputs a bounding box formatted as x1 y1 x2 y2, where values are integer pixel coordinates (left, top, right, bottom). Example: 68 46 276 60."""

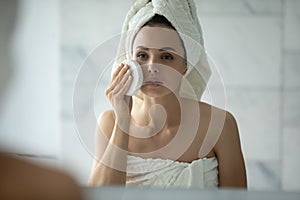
89 111 130 186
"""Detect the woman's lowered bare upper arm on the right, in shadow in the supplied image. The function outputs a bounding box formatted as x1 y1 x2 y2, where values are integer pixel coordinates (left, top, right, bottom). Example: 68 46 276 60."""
214 112 247 188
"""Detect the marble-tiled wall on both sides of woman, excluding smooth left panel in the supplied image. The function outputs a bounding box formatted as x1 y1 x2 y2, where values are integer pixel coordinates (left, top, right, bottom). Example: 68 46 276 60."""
61 0 300 190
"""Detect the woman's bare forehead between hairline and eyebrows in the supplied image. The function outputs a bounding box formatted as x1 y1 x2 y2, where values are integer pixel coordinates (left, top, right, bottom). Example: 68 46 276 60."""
133 26 184 55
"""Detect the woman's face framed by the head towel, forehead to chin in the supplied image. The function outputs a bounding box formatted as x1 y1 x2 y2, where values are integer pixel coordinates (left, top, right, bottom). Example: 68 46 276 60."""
133 26 186 97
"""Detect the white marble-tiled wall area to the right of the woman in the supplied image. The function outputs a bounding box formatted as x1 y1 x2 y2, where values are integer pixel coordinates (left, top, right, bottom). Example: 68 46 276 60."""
197 0 300 190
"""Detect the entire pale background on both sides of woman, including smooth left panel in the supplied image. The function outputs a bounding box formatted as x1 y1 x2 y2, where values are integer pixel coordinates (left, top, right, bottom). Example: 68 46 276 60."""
0 0 300 191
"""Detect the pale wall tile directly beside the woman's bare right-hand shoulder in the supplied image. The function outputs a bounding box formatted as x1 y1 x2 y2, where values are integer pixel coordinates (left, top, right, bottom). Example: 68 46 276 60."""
226 88 281 162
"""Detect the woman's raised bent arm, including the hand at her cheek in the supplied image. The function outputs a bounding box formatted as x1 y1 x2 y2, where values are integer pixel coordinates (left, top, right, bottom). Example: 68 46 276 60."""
89 64 132 185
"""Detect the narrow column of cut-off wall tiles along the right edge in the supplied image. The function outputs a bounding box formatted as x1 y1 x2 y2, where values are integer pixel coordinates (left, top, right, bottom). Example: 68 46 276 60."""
281 0 300 190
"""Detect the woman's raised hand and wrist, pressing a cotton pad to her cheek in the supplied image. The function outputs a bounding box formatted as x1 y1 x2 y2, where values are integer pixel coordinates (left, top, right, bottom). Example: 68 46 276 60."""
105 64 132 122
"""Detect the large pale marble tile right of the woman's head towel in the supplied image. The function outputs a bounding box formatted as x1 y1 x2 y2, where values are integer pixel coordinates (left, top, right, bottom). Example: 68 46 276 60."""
199 17 281 88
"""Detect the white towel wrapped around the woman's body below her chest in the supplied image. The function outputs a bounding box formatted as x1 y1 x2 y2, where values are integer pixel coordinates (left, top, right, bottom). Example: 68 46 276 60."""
126 156 218 189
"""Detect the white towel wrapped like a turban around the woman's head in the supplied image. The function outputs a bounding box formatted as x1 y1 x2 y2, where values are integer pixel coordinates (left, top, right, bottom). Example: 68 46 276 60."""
116 0 211 101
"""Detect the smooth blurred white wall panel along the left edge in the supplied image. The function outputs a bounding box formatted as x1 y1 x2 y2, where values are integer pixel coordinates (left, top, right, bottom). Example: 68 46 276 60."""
0 0 60 157
